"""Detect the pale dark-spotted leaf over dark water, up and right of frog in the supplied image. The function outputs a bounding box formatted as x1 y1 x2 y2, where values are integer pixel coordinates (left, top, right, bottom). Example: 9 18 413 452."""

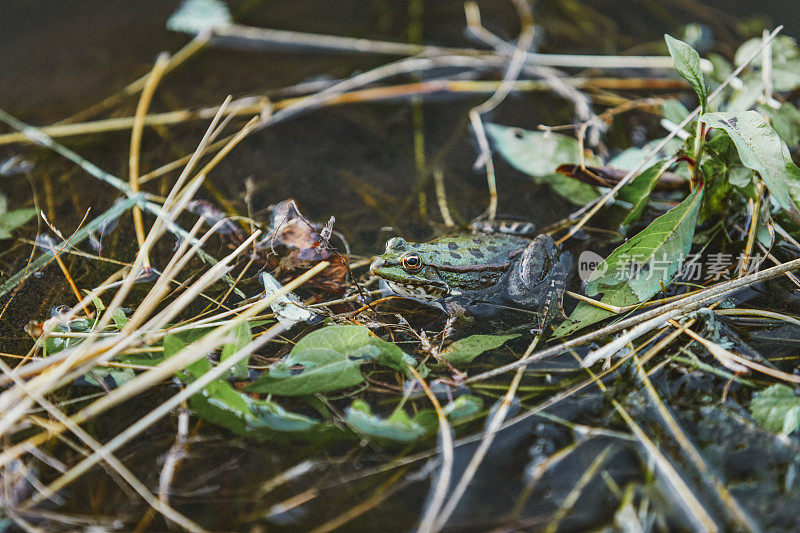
486 123 599 204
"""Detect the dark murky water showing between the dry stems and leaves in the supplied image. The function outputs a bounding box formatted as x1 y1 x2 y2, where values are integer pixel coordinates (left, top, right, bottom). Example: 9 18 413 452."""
0 0 800 531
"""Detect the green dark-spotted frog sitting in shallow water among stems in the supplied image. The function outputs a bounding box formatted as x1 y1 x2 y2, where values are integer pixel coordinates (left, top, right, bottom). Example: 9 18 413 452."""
370 233 571 325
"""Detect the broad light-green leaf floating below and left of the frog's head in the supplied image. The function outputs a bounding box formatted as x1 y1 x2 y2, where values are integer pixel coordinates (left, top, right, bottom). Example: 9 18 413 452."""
249 326 414 396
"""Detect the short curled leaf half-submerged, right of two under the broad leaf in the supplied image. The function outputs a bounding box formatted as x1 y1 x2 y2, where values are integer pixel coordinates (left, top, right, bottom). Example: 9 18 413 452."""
344 400 439 442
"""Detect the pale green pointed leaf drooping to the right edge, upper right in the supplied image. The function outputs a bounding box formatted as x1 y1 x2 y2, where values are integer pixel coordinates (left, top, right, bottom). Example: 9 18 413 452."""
700 111 800 221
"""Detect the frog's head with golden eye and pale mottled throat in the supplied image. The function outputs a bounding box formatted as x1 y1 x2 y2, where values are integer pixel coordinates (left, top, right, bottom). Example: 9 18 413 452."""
369 237 450 300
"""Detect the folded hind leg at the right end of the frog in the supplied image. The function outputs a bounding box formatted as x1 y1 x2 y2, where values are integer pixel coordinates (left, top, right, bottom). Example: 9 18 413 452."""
506 235 572 326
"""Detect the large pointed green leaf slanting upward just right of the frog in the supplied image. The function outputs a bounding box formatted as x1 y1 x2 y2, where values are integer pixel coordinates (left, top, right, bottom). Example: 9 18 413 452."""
554 188 703 337
